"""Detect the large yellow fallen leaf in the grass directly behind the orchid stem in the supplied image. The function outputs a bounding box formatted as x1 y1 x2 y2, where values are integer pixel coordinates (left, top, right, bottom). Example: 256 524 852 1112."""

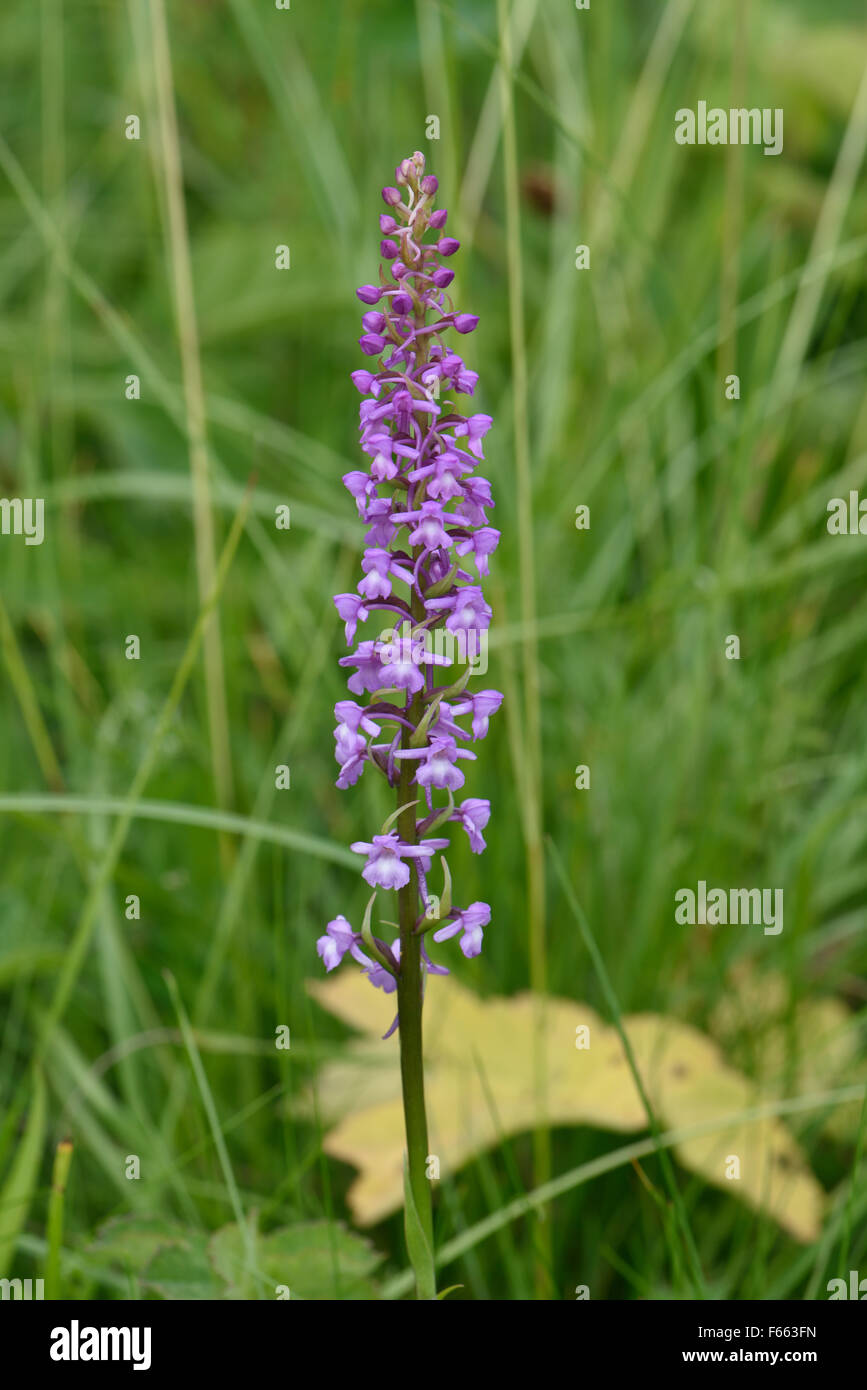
308 970 824 1241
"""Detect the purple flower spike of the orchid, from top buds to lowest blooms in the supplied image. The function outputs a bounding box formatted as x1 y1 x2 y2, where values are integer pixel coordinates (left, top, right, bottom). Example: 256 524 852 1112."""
317 153 503 1011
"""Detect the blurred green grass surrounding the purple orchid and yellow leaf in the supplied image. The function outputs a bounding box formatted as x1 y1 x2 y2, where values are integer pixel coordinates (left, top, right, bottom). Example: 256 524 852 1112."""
0 0 867 1300
